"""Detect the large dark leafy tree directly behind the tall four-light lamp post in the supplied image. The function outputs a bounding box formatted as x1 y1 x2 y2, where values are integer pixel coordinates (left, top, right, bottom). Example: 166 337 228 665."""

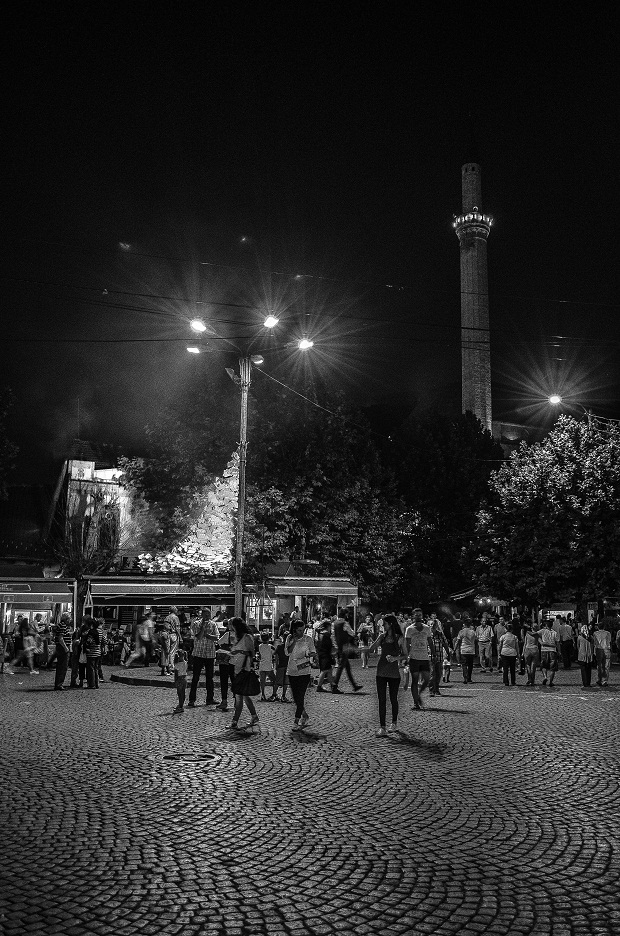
123 377 401 599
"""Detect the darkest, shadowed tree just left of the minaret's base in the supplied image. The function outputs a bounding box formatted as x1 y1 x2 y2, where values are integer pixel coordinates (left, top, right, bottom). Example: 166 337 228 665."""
393 413 503 602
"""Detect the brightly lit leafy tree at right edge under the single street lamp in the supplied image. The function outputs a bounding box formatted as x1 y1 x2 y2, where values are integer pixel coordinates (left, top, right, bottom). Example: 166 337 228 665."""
466 416 620 605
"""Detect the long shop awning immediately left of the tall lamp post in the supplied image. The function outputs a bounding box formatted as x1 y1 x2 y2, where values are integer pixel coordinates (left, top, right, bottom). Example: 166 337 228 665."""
90 581 235 607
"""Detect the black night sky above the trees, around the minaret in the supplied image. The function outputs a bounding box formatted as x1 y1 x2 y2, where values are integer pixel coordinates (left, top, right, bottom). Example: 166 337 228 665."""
0 2 620 481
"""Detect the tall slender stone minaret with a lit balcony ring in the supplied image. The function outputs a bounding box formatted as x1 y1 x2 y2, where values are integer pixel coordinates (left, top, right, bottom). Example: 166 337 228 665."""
454 163 493 431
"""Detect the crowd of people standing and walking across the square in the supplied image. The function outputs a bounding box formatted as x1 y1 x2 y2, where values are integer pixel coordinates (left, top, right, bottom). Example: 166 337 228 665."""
2 607 620 736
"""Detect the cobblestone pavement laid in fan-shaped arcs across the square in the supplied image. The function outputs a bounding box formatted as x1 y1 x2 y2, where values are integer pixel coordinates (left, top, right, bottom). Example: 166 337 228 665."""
0 664 620 936
